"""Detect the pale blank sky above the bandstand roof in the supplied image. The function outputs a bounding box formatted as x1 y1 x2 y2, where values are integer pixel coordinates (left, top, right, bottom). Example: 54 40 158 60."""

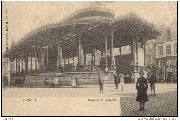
2 1 177 52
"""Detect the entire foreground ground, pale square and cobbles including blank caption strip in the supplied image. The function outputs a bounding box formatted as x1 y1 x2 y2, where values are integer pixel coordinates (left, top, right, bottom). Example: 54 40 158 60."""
2 84 177 116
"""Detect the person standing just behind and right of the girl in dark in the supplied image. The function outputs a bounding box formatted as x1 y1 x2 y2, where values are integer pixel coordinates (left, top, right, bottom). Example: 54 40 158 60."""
147 72 157 96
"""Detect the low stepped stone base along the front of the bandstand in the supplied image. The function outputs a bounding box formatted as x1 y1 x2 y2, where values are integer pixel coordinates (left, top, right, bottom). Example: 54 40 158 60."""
24 72 114 86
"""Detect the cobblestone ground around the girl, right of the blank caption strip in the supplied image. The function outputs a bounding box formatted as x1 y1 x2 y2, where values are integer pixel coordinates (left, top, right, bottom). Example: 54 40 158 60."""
121 84 177 116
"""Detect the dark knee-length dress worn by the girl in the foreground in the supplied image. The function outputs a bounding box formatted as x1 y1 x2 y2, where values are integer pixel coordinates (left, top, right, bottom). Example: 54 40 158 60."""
136 77 148 102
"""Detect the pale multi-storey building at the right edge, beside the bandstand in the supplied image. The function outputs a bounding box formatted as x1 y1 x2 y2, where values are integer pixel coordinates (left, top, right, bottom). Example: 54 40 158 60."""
156 28 177 83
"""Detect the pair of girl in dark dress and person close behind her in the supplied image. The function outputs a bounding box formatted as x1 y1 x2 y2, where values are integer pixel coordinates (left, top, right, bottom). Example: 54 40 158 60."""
136 70 156 111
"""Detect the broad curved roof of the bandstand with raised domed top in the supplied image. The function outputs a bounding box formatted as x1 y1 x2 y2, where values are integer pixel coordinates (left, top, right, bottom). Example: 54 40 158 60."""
4 9 160 58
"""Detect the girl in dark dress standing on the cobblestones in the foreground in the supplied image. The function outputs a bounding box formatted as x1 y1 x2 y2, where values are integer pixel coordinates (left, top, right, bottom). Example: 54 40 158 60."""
136 70 148 111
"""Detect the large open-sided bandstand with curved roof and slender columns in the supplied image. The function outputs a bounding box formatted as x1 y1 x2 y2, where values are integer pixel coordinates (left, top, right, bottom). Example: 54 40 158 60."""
4 8 160 84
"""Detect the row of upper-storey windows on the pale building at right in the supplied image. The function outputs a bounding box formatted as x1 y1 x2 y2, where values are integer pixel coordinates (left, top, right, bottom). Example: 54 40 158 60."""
158 43 177 56
